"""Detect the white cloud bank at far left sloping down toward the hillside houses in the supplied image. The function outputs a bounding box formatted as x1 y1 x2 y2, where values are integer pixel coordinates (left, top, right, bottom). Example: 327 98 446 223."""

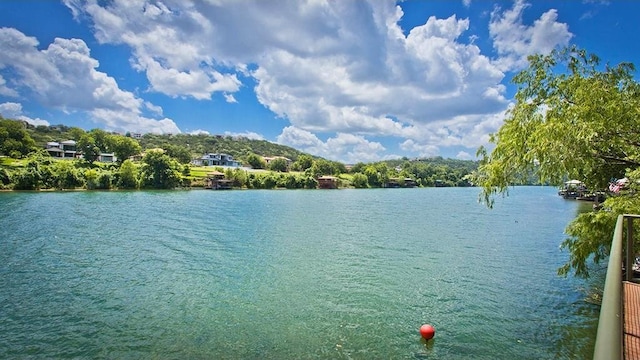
0 28 180 133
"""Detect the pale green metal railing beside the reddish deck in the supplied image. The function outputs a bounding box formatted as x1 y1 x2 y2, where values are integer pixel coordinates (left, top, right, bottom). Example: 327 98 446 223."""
593 214 640 360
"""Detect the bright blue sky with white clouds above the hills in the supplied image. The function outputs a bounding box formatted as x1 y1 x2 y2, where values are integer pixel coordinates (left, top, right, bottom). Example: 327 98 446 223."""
0 0 640 163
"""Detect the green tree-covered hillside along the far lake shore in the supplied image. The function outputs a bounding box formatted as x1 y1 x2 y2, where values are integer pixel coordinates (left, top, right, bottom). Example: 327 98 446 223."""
0 117 477 190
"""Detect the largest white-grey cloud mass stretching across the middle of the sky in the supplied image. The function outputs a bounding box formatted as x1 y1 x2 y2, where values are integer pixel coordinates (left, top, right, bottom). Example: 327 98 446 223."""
65 0 507 153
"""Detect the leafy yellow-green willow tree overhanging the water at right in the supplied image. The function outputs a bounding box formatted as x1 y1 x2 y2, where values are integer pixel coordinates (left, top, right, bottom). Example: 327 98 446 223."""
474 47 640 276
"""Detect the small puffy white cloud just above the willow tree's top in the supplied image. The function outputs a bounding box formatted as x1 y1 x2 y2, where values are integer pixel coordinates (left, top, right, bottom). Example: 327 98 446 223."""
489 0 573 71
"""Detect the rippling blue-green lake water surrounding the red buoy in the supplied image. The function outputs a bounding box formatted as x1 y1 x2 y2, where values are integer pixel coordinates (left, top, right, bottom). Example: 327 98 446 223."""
0 187 600 359
